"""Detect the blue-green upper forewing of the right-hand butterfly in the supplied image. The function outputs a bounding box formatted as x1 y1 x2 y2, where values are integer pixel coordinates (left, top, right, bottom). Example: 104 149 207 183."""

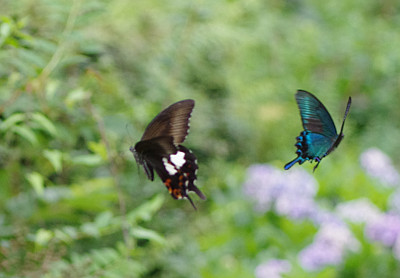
296 90 337 138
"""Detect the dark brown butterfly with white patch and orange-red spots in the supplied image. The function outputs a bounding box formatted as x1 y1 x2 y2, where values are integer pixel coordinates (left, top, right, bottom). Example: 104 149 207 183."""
129 99 206 209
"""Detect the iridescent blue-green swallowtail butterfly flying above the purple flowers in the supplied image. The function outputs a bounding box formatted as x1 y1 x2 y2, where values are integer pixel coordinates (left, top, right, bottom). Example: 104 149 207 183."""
285 90 351 171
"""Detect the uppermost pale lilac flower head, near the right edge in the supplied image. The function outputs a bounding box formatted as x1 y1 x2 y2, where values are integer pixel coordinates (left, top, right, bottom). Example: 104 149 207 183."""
360 148 400 186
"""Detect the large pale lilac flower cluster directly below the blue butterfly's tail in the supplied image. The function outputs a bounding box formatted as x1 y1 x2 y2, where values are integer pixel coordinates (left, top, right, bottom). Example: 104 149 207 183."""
243 164 317 219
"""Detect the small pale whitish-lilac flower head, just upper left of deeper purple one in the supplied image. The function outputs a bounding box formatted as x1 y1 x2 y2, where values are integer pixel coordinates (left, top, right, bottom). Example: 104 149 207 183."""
335 198 381 223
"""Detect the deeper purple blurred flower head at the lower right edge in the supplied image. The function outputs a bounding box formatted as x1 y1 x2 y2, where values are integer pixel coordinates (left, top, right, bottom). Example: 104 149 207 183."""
365 214 400 246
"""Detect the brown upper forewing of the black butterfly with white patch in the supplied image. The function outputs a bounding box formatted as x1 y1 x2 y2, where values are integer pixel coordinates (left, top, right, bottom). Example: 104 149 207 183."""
141 99 194 144
